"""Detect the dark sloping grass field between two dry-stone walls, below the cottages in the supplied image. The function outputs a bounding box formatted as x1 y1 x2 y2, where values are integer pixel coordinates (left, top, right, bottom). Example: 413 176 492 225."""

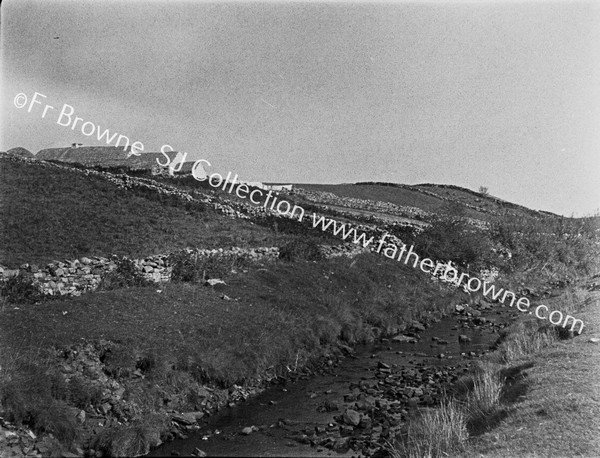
0 160 276 267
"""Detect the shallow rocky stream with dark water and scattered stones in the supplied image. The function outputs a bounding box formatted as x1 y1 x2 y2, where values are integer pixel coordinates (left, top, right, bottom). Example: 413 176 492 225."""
149 304 519 456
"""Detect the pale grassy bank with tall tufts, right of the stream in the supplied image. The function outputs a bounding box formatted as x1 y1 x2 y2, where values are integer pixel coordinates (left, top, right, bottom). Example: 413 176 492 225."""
391 288 600 458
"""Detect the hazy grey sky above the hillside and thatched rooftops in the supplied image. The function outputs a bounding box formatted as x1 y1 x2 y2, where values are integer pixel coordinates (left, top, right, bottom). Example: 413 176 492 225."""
0 0 600 216
